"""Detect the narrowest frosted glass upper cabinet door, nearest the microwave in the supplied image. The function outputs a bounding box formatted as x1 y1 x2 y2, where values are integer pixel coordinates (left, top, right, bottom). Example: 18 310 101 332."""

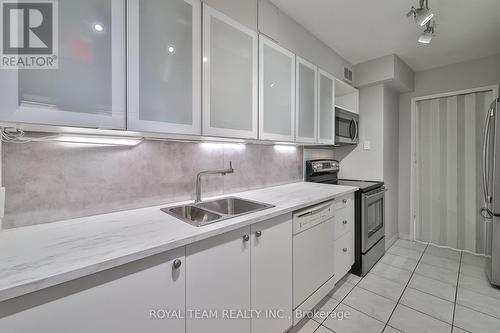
318 69 335 144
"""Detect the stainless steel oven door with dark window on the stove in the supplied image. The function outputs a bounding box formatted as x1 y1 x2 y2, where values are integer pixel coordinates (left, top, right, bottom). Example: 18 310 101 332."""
361 187 387 253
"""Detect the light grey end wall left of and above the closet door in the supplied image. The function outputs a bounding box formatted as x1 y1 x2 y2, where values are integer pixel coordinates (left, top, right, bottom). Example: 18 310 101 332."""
398 54 500 238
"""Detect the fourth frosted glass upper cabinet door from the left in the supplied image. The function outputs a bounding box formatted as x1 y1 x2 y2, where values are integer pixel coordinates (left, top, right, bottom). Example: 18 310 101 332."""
259 36 295 141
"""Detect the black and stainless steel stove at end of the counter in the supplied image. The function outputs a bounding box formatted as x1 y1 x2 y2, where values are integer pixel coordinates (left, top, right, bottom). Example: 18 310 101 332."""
306 160 387 276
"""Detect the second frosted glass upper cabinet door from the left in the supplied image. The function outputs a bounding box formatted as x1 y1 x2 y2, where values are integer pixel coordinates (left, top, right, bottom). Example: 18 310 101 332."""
127 0 201 135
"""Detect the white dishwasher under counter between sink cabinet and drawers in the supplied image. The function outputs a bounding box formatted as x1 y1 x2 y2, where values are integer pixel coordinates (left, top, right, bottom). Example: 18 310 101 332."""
293 201 335 310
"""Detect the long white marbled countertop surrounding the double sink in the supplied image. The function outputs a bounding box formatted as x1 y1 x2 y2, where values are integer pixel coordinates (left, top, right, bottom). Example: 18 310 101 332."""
0 183 357 301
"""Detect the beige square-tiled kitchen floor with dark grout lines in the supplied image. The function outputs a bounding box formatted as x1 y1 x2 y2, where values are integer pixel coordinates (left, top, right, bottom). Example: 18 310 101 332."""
290 240 500 333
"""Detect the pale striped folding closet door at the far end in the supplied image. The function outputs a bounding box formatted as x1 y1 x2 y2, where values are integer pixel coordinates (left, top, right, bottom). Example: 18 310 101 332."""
415 91 493 253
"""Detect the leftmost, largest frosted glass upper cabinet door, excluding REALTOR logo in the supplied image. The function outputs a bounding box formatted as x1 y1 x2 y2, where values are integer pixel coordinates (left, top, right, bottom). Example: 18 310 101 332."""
0 0 125 129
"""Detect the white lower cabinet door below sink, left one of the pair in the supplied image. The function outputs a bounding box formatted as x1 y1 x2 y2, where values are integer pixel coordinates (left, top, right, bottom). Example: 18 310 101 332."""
186 227 251 333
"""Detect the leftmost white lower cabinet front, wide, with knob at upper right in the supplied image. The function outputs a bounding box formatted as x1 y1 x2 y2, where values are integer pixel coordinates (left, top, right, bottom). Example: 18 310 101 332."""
0 248 186 333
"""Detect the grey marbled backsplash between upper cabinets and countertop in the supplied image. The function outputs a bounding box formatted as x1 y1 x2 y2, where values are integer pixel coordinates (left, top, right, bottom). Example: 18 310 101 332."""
2 141 303 229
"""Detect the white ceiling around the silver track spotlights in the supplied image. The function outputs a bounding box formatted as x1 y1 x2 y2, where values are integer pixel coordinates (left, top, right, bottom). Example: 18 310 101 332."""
271 0 500 71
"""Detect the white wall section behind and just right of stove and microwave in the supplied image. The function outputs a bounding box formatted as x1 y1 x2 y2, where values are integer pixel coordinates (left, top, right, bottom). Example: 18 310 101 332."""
333 84 399 247
